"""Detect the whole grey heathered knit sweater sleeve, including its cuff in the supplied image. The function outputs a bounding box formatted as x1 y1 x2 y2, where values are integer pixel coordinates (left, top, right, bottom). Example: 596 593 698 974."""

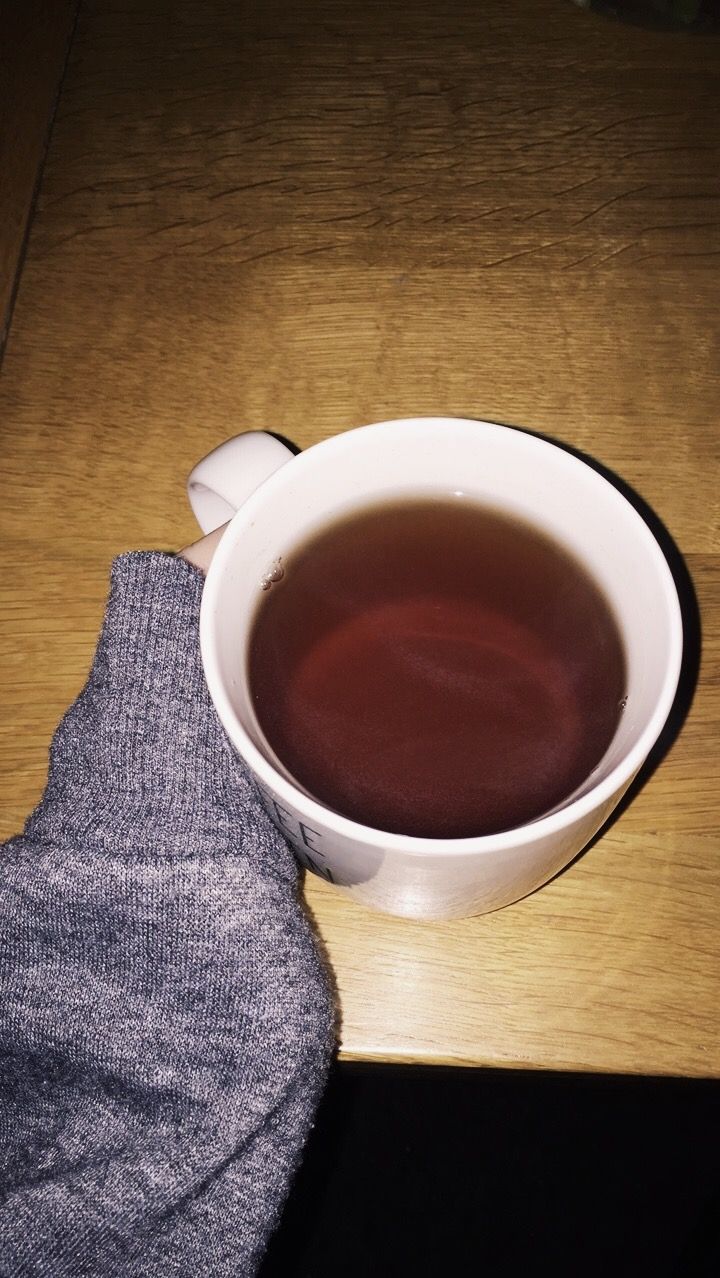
0 552 334 1278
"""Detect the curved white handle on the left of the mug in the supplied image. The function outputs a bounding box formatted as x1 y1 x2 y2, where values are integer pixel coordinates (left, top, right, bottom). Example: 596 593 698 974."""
188 431 294 533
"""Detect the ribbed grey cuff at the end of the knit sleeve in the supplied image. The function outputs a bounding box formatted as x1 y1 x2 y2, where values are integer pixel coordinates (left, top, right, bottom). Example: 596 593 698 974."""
27 552 291 855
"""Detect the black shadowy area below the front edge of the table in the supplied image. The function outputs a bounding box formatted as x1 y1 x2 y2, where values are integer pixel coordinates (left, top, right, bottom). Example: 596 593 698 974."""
261 1065 720 1278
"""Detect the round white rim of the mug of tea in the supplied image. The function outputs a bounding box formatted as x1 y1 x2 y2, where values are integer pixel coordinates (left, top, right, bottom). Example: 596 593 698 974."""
200 417 683 856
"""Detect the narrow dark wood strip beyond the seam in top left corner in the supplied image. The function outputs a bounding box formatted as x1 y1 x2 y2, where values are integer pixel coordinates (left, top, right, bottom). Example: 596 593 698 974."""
0 0 78 358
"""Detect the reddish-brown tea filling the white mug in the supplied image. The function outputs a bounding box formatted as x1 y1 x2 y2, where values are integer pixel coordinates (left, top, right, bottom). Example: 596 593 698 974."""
249 496 625 838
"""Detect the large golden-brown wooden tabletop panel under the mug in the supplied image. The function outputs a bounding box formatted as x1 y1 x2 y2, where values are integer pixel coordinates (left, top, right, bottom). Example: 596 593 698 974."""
0 0 720 1076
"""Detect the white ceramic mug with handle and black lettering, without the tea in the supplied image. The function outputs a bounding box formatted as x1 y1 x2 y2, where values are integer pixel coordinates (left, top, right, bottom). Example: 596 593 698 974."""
188 418 682 919
